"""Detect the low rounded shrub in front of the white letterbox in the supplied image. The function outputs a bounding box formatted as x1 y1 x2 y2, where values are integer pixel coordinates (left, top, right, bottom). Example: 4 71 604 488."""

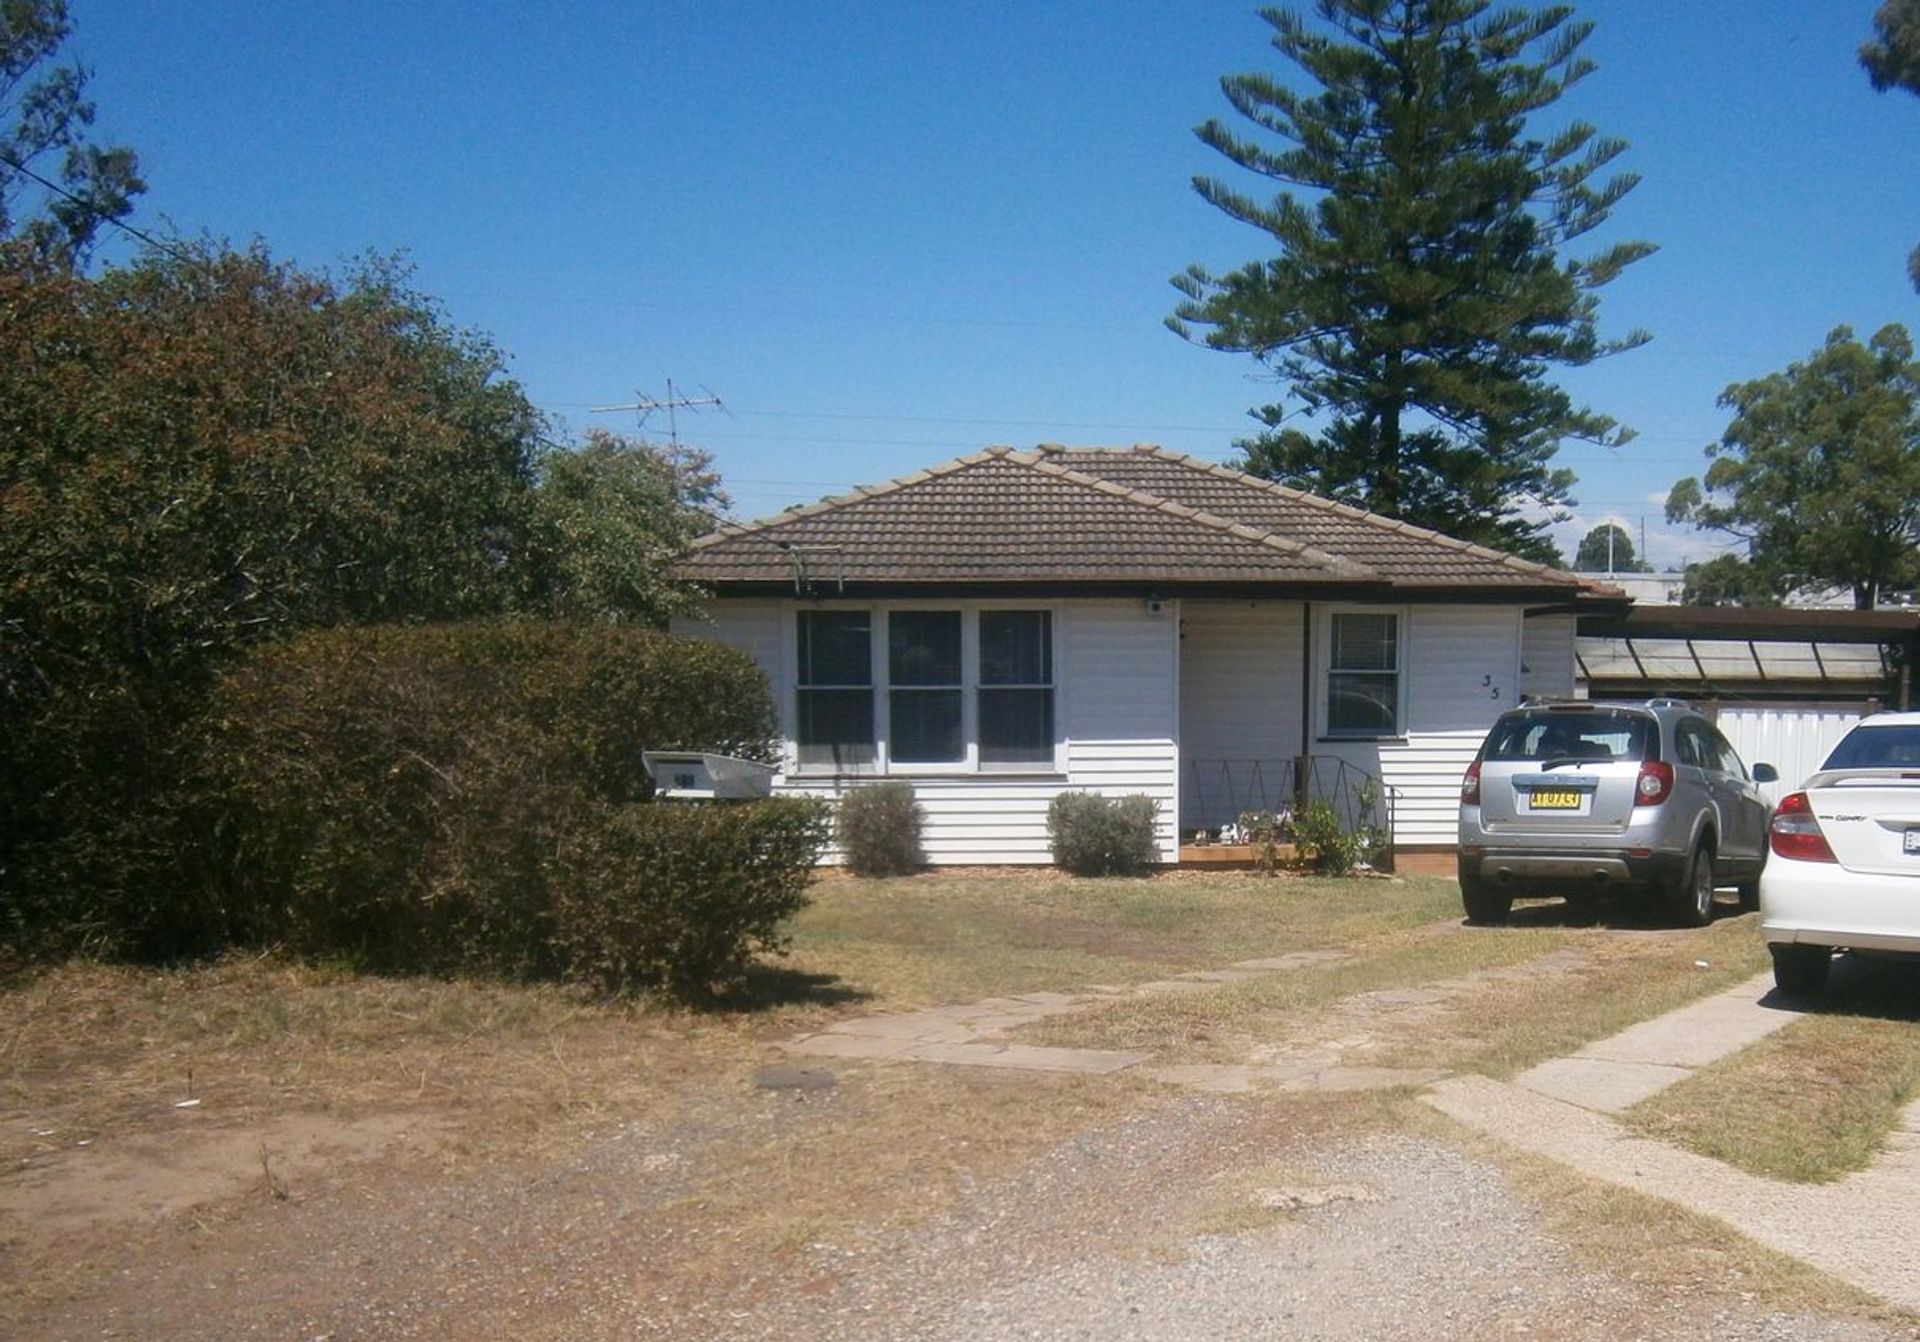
549 797 828 1002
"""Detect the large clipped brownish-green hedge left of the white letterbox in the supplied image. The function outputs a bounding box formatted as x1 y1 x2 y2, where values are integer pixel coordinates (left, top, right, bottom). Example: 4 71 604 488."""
190 620 774 973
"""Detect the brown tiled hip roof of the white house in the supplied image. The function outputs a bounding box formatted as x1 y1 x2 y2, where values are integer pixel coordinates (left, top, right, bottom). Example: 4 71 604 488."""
685 447 1603 595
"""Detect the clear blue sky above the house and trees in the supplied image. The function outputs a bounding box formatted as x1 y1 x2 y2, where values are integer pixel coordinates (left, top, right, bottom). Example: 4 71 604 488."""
73 0 1920 561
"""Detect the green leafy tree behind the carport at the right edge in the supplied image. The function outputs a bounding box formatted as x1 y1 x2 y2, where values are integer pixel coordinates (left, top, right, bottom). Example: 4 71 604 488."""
1667 326 1920 611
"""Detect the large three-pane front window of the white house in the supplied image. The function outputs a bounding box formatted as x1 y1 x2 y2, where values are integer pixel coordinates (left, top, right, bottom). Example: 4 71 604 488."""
797 609 1056 772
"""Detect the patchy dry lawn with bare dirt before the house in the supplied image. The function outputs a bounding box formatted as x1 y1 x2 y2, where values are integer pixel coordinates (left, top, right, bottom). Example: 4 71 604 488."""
0 872 1896 1338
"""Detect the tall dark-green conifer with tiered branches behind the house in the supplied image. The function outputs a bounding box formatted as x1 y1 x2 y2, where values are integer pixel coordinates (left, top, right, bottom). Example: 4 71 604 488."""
1167 0 1653 557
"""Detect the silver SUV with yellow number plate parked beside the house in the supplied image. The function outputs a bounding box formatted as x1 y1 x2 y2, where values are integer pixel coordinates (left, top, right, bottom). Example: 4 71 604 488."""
1459 699 1780 927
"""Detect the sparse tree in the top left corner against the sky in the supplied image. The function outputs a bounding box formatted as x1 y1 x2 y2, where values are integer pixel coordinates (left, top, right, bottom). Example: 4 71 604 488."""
0 0 146 265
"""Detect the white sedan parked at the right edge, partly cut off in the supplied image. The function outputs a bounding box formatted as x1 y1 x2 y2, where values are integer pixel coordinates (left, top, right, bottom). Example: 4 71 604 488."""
1761 712 1920 993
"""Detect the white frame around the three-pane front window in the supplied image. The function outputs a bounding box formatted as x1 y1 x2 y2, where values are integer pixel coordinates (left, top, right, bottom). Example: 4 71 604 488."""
780 597 1068 779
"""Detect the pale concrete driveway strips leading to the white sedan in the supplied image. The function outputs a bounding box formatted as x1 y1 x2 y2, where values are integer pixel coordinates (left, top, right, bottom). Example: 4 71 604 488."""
1425 975 1920 1309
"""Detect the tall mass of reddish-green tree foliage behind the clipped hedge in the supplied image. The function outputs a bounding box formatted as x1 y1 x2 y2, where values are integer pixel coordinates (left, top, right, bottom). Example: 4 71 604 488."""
0 244 714 945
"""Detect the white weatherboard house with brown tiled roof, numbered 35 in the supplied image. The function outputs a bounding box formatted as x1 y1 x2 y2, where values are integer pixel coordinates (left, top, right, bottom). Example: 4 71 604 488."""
676 447 1626 864
